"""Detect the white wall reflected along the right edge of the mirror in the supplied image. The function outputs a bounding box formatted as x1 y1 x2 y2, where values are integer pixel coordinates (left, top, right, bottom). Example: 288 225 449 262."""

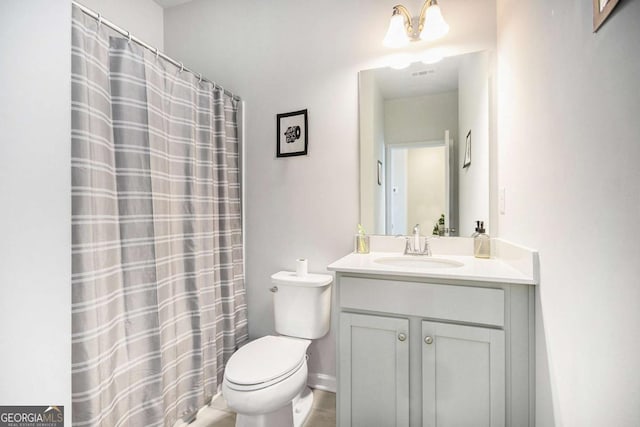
455 51 493 236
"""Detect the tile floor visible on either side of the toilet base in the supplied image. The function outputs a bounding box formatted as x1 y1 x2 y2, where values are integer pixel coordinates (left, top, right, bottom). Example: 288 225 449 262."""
181 390 336 427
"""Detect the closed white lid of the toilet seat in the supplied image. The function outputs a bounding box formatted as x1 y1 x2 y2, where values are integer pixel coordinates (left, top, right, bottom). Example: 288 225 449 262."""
224 335 310 385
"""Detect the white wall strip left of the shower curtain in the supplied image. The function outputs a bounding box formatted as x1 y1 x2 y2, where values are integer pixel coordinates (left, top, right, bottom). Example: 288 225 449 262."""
0 0 71 426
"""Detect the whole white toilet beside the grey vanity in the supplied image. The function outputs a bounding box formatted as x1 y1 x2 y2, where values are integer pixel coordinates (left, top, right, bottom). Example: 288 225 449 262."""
222 271 333 427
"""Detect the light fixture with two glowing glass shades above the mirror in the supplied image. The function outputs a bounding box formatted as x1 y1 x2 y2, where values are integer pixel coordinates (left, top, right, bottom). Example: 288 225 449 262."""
382 0 449 47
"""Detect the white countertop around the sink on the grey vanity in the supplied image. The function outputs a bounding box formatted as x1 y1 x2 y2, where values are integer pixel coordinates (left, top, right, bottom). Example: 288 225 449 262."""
327 252 538 285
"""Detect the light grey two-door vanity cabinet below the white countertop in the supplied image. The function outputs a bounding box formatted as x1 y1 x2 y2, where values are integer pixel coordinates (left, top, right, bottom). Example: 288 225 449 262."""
336 271 534 427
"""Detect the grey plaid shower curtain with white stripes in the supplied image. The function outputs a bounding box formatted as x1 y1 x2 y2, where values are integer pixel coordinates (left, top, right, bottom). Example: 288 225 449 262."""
72 6 247 427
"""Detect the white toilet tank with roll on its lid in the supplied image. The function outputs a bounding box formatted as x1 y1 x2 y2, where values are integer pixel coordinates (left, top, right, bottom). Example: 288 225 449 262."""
271 271 333 339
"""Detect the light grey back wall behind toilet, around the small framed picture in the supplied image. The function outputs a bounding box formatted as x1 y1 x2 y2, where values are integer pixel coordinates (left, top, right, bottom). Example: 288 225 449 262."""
165 0 495 388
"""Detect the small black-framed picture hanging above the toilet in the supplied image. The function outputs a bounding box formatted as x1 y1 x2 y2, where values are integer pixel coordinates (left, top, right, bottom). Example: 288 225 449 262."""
276 109 309 157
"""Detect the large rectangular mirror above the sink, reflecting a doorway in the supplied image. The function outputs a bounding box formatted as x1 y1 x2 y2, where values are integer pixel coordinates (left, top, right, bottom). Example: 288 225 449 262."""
359 52 493 236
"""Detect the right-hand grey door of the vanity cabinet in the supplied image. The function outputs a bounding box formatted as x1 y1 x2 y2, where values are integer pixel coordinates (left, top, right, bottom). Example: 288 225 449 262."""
422 321 506 427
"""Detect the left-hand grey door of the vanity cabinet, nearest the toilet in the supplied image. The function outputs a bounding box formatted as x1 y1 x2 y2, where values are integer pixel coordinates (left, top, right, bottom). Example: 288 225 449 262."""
338 313 409 427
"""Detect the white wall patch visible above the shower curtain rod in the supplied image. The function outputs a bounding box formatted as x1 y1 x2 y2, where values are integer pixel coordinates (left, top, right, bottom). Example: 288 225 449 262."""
78 0 164 52
